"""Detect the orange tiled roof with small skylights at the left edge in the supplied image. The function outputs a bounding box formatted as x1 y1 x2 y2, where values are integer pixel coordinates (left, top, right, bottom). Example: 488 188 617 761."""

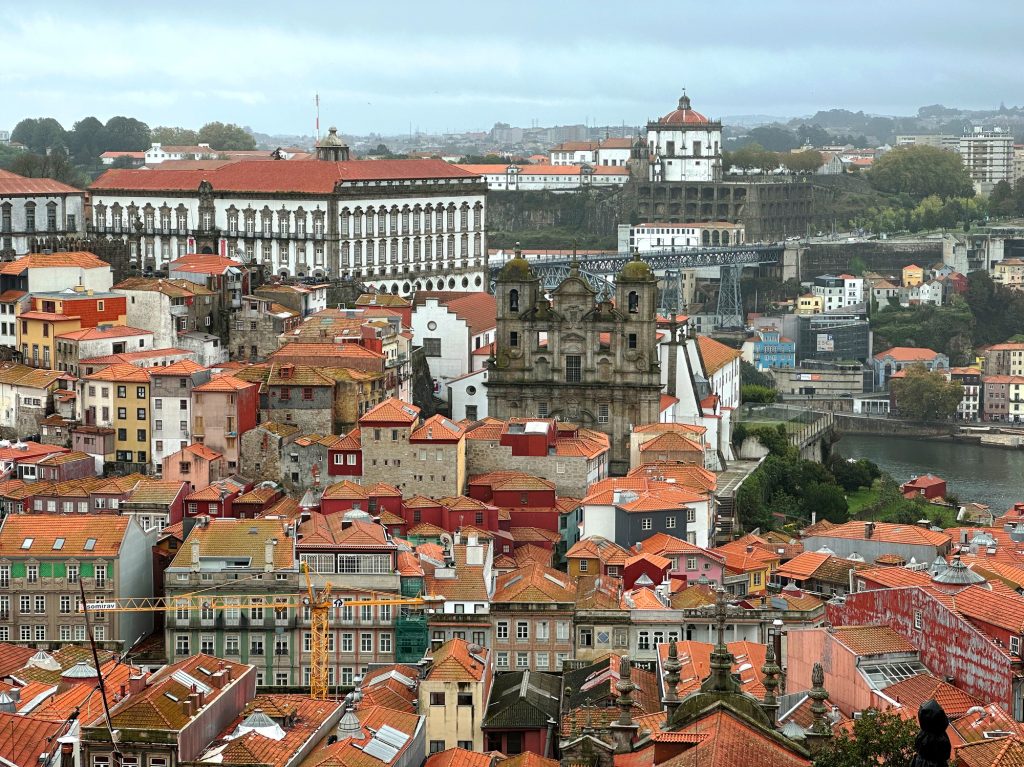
0 514 131 559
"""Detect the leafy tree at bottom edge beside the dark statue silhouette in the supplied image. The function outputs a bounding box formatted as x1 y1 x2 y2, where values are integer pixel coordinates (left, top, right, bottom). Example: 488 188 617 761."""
814 709 919 767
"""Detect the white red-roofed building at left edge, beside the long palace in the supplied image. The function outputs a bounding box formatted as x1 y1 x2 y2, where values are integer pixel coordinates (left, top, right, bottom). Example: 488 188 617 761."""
0 170 86 252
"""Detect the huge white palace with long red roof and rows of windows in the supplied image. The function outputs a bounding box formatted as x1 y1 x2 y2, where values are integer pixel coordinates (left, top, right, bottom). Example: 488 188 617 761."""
90 128 487 293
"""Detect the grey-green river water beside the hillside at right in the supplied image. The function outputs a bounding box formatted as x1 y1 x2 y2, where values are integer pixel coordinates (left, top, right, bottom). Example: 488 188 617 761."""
836 434 1024 515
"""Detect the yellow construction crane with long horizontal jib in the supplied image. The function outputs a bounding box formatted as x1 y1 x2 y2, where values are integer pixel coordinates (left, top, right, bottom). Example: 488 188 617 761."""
79 563 444 700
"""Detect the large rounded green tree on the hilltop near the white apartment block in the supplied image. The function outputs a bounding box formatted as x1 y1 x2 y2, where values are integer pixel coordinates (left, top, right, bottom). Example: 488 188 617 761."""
867 145 974 200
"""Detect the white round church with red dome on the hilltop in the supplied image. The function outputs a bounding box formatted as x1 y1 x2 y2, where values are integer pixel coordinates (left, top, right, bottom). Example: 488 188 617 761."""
647 93 722 181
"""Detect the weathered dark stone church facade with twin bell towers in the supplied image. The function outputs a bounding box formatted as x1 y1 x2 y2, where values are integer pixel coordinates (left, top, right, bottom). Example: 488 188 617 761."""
486 253 662 474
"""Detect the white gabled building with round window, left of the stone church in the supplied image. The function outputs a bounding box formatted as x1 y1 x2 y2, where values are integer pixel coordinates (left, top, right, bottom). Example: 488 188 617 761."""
413 292 498 399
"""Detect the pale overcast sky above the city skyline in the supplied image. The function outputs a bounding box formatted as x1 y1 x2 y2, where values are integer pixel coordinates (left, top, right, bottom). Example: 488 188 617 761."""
0 0 1024 134
